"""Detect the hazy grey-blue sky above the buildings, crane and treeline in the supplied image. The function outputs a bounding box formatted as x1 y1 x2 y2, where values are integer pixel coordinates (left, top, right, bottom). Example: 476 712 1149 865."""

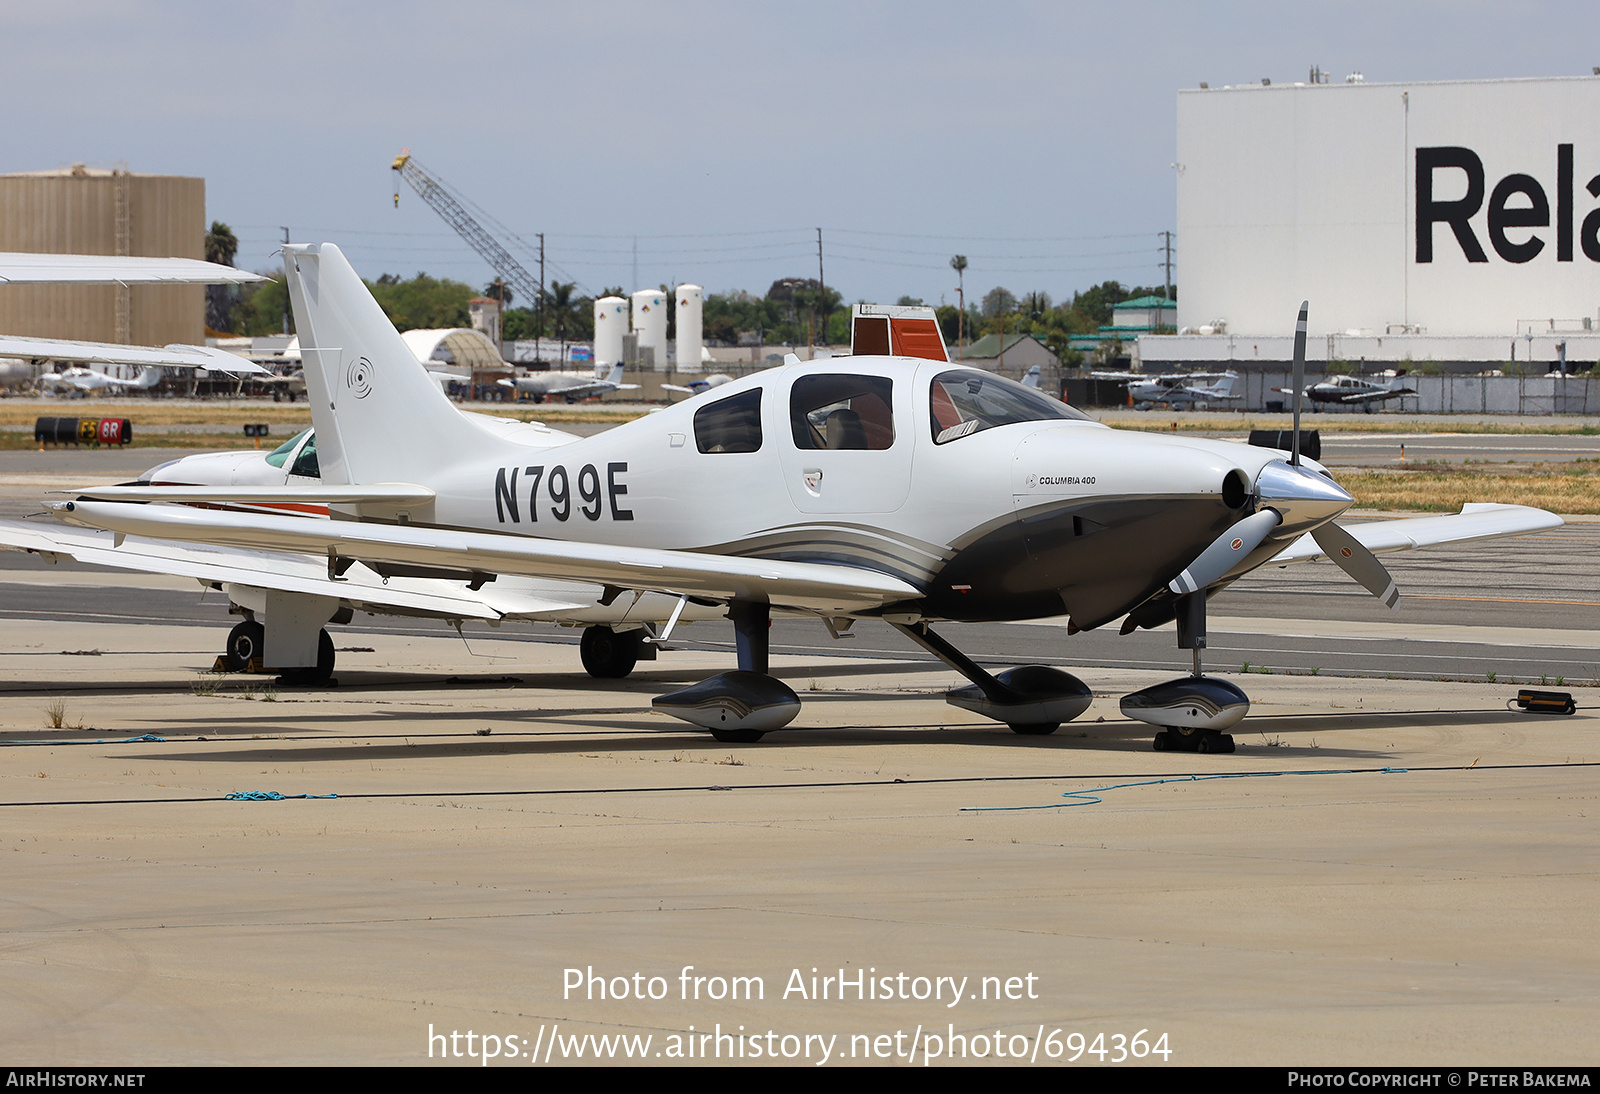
0 0 1600 304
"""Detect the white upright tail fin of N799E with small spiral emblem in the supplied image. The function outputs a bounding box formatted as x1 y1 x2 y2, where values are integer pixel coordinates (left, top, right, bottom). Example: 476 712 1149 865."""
283 243 493 485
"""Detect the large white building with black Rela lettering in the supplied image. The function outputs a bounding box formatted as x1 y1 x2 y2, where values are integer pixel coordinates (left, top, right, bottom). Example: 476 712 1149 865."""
1139 77 1600 406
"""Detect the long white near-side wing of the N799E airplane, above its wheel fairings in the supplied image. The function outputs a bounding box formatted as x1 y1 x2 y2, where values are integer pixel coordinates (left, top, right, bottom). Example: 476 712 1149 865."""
53 501 922 614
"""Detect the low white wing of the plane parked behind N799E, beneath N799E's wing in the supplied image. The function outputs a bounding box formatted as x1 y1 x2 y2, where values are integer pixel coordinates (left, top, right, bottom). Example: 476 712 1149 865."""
0 520 594 621
